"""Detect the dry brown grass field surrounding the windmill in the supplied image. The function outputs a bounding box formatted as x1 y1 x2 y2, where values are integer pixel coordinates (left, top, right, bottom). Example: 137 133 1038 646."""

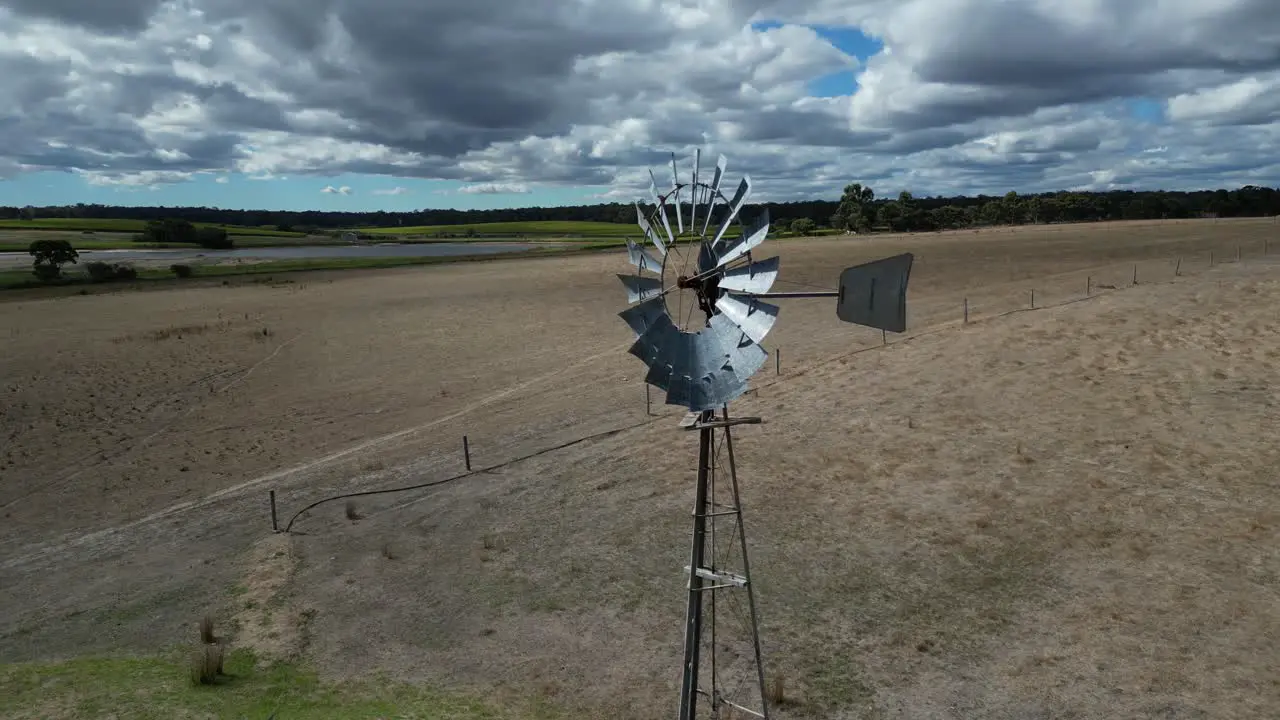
0 219 1280 719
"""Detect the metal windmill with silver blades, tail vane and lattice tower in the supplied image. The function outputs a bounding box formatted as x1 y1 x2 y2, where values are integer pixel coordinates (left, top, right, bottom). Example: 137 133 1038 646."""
618 149 913 720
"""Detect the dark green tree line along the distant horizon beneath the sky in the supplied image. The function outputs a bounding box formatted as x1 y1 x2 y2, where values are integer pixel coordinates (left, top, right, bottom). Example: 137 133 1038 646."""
0 183 1280 232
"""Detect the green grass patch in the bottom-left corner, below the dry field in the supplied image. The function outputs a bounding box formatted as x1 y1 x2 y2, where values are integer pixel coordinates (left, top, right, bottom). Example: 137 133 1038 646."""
0 651 557 720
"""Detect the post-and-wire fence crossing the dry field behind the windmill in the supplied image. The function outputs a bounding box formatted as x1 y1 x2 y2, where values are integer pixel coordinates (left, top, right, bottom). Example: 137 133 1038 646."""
270 241 1280 533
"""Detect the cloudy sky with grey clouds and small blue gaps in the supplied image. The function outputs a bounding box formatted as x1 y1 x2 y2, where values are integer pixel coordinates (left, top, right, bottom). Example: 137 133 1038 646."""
0 0 1280 211
